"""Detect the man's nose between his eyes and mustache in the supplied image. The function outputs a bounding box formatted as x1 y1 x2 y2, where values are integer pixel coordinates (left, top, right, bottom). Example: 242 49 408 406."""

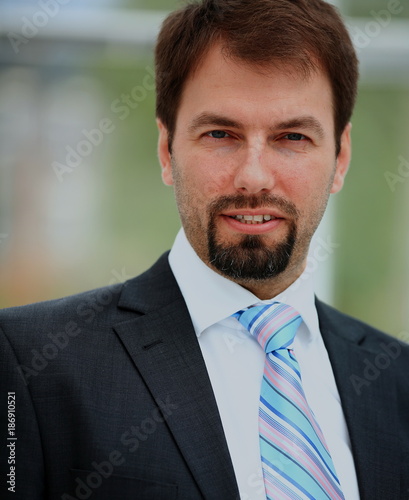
234 146 275 194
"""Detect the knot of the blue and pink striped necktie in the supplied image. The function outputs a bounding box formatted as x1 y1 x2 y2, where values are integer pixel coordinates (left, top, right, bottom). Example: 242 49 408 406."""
233 302 302 353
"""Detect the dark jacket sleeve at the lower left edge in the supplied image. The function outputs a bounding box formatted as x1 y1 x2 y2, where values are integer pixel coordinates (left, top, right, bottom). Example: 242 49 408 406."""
0 327 46 500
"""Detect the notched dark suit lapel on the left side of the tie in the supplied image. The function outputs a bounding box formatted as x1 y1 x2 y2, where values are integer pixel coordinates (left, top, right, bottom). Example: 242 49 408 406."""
115 254 238 498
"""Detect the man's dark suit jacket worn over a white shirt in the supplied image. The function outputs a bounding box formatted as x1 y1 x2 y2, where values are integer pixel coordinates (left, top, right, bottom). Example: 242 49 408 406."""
0 255 409 500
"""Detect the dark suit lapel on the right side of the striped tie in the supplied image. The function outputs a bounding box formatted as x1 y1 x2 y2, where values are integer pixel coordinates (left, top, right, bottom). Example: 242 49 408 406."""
317 302 400 499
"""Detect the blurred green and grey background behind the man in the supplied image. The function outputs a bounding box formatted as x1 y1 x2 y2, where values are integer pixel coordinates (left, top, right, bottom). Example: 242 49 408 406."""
0 0 409 341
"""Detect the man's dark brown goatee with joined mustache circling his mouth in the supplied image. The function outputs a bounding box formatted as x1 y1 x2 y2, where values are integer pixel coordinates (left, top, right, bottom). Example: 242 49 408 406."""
207 195 298 282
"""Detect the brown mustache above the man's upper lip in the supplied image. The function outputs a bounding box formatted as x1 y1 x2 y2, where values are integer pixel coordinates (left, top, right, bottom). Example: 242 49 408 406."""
209 193 300 219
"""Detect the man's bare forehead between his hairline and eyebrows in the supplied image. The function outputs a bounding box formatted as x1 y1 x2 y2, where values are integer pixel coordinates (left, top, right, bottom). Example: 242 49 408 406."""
176 45 334 132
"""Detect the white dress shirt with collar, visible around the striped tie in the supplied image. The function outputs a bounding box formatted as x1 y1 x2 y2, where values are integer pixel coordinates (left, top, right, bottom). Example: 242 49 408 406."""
169 229 359 500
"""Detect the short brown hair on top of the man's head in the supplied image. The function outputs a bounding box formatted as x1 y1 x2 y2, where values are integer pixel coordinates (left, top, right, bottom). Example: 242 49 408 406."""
155 0 358 154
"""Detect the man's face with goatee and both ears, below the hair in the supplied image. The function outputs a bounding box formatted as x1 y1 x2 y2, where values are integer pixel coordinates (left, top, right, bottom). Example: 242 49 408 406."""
159 46 350 289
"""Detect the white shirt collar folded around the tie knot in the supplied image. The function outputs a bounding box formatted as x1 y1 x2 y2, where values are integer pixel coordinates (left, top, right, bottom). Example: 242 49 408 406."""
169 229 319 336
